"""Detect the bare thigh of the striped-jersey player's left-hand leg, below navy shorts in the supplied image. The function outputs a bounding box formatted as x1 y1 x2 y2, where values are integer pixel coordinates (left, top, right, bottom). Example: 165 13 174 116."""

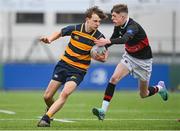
45 80 61 97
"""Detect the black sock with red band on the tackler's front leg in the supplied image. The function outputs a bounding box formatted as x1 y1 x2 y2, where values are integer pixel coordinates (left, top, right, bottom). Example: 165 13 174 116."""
104 83 116 102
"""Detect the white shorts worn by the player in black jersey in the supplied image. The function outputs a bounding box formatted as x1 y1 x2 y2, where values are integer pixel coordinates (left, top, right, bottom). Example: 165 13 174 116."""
121 52 152 81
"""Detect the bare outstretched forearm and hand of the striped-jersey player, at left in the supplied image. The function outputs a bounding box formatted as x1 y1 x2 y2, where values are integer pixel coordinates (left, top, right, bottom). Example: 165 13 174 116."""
40 32 61 44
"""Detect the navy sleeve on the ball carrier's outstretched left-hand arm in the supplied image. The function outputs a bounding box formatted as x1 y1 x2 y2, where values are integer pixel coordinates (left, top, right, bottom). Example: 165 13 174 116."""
61 25 76 36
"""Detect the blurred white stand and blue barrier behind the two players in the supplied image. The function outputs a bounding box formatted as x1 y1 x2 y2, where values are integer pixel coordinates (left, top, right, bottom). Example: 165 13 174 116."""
0 0 180 91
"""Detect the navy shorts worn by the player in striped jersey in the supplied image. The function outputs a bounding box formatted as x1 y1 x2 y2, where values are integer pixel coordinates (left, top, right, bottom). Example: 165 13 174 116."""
52 60 86 86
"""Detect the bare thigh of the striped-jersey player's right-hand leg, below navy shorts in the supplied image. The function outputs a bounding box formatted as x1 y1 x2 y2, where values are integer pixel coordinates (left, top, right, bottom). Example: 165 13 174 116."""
61 81 77 95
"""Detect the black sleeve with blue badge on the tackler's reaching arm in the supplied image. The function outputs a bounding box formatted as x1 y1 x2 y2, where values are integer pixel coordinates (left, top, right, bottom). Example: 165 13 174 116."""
110 24 139 44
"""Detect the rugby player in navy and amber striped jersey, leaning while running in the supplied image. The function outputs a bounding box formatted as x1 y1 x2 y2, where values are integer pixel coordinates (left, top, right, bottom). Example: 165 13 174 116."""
37 6 107 127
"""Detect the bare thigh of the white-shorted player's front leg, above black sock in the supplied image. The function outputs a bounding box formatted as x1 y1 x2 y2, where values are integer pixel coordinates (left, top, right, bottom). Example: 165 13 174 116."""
112 63 129 80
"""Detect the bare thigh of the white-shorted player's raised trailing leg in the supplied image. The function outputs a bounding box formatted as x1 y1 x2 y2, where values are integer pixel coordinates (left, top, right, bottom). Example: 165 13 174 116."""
138 80 149 94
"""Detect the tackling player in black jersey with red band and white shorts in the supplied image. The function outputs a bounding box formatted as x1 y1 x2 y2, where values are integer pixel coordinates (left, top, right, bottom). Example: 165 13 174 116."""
92 4 168 120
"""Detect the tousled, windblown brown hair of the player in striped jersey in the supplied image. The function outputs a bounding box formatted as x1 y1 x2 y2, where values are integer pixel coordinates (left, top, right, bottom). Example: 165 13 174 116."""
85 6 108 20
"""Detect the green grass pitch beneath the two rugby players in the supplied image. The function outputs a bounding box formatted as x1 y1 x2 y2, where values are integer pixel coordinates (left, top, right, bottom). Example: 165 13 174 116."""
0 91 180 130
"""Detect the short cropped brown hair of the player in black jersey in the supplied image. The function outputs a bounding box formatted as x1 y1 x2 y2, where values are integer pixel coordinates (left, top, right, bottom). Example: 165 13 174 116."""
111 4 128 14
